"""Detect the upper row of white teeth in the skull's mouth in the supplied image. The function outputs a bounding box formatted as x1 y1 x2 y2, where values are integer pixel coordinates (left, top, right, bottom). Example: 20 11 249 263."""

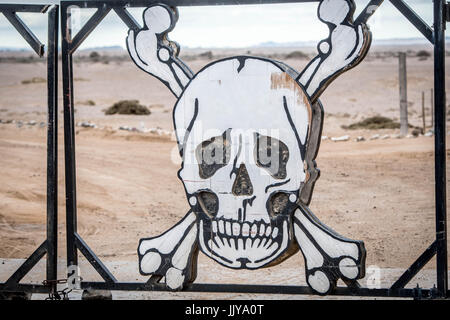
211 219 279 243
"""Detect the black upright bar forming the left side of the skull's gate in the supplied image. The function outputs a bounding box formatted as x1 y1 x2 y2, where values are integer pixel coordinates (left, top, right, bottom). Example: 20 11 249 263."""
61 3 78 272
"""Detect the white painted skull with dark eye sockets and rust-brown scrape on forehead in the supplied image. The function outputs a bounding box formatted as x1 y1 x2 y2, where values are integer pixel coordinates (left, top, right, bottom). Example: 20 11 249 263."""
174 57 311 269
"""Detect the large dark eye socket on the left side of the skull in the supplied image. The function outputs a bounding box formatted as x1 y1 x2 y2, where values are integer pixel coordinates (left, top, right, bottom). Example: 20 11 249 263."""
195 130 231 179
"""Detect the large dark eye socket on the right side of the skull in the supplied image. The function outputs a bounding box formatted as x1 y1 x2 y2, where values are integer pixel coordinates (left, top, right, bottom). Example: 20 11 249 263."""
255 133 289 179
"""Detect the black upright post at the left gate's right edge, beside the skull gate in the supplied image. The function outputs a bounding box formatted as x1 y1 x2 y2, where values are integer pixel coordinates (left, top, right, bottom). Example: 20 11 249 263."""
47 5 59 292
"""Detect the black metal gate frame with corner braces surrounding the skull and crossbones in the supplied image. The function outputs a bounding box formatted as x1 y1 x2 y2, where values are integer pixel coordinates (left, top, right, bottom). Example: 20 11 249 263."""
61 0 449 299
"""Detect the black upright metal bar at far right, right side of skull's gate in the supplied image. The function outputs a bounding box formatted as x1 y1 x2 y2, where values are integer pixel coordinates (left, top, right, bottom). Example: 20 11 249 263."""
434 0 448 297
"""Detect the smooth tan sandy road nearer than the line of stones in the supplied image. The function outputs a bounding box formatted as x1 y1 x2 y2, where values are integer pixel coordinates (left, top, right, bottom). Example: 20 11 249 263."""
0 124 446 267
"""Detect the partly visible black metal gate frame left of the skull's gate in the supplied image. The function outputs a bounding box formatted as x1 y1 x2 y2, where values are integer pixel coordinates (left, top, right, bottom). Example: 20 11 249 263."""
0 4 59 295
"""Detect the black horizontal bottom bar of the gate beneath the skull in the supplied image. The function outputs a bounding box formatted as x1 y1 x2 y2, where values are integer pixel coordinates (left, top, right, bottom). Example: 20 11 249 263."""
80 281 442 298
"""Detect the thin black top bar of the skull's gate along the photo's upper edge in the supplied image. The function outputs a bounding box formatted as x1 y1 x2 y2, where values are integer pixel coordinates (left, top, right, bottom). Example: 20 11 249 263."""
61 0 321 8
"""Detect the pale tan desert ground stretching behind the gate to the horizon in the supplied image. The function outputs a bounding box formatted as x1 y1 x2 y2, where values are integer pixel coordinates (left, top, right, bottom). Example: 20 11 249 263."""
0 47 450 298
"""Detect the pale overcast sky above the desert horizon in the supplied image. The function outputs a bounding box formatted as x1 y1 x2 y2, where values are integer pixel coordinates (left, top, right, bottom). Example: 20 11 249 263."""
0 0 433 49
